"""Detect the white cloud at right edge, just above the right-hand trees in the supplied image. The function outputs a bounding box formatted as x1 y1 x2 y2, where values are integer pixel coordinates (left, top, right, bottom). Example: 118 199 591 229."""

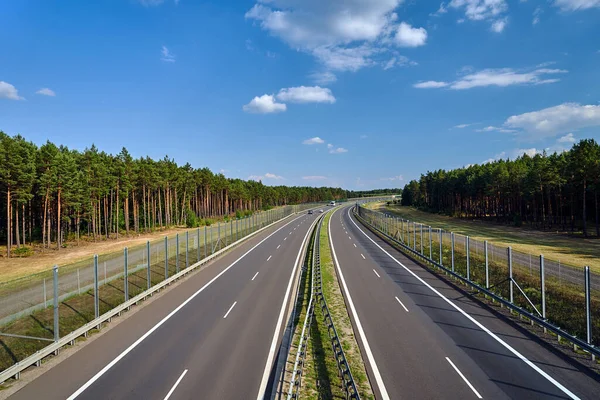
504 103 600 139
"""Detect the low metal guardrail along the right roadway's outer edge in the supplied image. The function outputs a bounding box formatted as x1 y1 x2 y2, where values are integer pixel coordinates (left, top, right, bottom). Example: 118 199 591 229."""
353 205 600 360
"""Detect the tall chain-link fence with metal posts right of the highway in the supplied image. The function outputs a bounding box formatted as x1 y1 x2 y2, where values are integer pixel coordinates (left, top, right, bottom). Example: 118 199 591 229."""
358 207 600 346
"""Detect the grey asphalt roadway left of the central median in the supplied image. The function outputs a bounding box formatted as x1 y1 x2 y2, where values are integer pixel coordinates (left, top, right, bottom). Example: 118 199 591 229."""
11 214 317 400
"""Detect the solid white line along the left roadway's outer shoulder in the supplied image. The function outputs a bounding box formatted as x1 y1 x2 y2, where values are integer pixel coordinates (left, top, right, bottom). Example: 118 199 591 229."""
67 217 300 400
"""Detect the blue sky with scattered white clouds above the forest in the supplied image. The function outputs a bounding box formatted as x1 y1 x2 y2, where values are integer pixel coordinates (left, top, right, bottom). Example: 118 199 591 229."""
0 0 600 189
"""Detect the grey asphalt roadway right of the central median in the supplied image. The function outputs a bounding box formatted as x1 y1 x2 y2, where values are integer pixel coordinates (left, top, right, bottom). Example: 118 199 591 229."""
330 207 600 399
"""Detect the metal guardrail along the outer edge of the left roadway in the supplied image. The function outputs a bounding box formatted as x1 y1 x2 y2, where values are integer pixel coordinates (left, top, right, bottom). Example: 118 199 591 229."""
0 213 295 384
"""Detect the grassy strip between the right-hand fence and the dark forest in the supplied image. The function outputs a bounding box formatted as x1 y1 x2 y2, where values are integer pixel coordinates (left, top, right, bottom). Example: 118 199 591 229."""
376 203 600 273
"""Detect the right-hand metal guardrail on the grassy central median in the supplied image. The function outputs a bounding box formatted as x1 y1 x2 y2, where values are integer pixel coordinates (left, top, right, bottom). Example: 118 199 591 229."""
313 211 360 400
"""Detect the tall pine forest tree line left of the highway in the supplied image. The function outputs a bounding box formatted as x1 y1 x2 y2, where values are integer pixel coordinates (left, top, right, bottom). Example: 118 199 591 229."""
0 131 347 257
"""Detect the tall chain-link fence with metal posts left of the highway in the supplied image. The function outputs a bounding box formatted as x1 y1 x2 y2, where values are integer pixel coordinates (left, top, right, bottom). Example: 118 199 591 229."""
0 203 316 371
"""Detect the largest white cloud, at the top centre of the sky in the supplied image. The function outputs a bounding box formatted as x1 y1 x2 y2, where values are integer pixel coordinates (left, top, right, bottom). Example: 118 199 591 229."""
245 0 426 71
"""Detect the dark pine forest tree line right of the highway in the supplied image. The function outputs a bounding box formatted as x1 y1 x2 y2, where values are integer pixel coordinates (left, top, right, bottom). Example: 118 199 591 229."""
401 139 600 236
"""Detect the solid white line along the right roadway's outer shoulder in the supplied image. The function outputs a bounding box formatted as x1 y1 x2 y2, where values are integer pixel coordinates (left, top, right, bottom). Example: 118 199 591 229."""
348 209 579 399
